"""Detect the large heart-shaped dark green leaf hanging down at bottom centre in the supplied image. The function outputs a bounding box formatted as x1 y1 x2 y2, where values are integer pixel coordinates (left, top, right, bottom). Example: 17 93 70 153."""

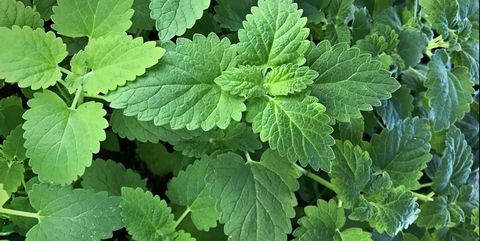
207 150 299 241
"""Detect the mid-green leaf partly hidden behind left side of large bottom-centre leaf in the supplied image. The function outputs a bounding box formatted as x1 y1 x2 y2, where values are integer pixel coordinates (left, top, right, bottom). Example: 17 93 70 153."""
166 157 220 231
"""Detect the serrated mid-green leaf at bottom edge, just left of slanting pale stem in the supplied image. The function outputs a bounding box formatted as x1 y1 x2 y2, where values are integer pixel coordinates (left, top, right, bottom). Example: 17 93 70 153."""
120 187 180 241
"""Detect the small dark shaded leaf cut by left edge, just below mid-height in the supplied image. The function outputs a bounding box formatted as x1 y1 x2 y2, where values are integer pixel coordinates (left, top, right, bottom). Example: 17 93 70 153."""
2 125 26 161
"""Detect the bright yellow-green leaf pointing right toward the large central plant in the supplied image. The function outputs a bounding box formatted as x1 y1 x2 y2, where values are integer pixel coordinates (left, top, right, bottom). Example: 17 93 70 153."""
69 35 165 95
